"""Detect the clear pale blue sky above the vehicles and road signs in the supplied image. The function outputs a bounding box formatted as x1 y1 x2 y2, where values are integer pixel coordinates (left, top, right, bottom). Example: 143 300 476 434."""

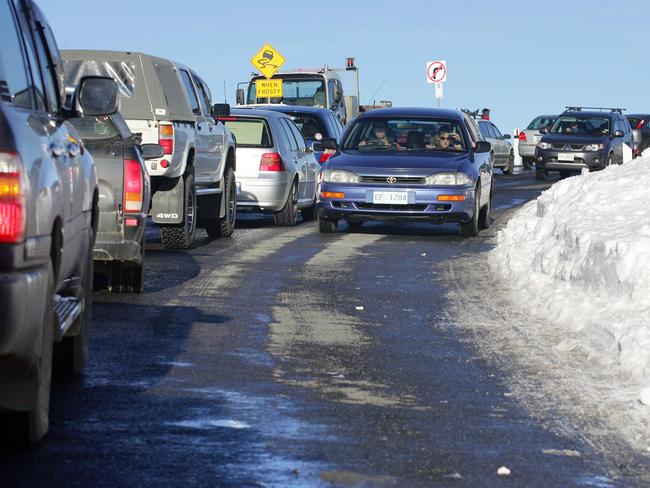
43 0 650 132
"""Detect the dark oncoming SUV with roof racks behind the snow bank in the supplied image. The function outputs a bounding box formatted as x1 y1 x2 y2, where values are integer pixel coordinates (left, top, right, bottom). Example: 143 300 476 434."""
535 107 634 179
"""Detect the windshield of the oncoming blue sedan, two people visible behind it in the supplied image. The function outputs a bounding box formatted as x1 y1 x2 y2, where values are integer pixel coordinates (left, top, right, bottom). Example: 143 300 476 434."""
342 117 467 152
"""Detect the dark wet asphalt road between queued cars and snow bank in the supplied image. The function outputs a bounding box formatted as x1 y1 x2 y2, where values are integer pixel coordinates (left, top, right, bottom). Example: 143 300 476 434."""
0 171 647 487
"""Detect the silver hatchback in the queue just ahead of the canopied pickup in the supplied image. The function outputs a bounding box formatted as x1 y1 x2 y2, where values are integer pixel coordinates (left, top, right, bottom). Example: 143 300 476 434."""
219 108 320 225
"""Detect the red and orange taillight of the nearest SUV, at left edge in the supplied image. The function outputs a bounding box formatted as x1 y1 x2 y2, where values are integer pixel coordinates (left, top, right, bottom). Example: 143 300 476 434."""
0 151 25 244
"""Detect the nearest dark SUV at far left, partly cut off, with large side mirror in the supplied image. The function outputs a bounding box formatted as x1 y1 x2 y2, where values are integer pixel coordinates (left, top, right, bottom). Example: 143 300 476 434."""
0 0 117 444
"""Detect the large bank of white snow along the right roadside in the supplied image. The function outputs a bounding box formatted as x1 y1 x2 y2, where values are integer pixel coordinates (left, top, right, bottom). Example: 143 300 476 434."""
490 151 650 404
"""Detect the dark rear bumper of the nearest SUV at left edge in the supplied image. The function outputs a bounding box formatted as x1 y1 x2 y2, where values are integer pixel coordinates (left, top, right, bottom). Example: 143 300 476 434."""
0 266 47 384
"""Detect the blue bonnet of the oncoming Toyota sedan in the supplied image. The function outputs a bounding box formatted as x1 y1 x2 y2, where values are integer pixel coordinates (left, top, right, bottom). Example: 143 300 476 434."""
329 151 469 177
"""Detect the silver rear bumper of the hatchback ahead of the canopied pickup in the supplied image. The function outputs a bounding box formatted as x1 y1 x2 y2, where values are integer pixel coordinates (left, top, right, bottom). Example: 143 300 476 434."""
237 173 293 212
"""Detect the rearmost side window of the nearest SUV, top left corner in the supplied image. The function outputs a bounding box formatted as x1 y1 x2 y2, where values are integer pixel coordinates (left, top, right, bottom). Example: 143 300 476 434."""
0 0 33 109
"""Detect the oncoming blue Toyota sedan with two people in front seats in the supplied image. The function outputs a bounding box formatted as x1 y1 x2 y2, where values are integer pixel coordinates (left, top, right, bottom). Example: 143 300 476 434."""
318 108 493 237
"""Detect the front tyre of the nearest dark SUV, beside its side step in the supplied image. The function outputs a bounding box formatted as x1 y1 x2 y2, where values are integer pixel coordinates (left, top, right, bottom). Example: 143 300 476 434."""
55 238 94 376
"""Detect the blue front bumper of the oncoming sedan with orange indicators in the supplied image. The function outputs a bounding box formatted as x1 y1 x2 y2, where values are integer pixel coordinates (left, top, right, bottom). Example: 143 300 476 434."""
318 182 475 224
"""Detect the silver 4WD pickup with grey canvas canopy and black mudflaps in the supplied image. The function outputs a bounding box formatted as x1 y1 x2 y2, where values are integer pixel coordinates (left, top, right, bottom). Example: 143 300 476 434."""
62 50 236 249
